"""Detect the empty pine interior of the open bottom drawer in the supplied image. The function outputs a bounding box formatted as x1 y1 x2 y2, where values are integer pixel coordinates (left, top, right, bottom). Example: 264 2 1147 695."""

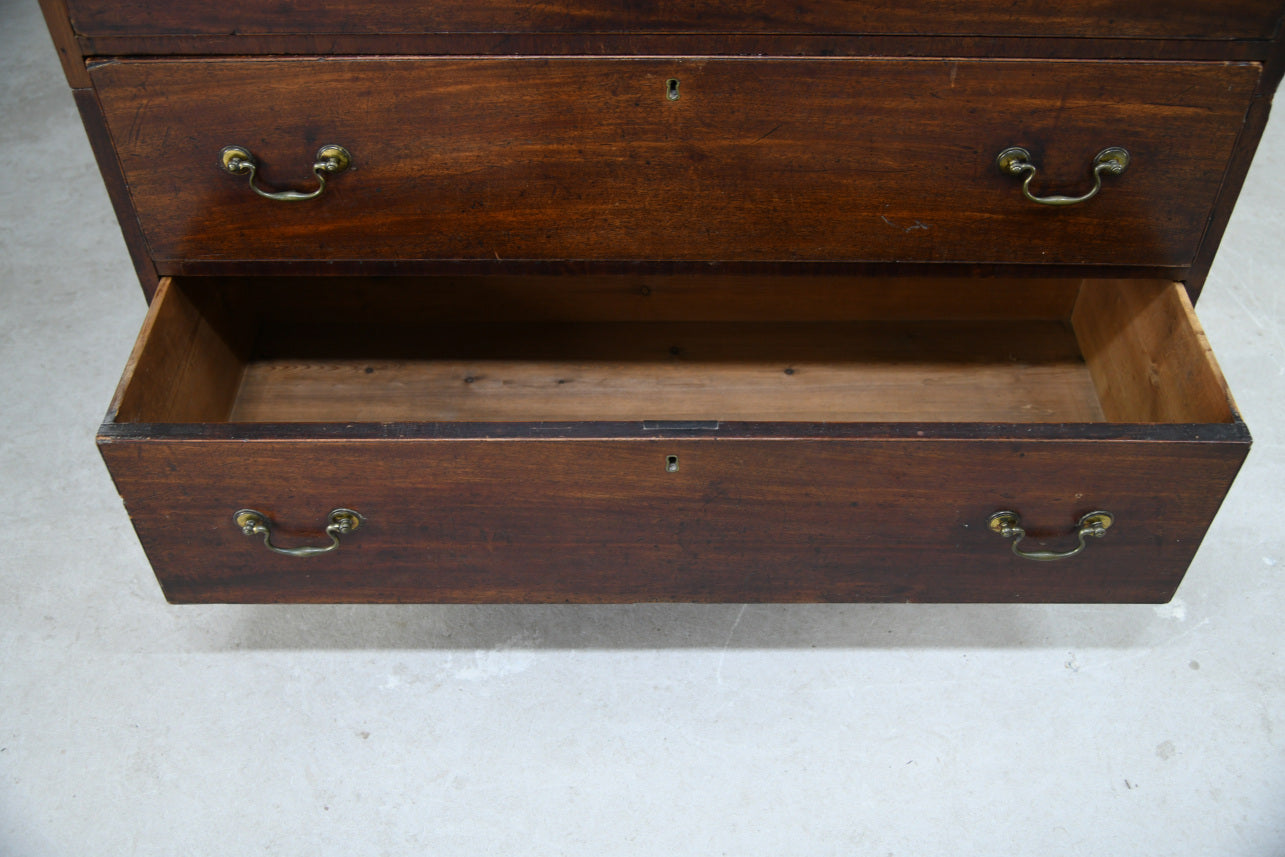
109 276 1236 424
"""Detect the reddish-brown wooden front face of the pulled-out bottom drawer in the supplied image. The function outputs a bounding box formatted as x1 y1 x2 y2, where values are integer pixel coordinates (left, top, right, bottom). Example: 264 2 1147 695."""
102 436 1248 603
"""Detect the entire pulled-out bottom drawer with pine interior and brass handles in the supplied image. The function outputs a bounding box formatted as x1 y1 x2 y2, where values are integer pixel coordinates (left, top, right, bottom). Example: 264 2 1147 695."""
99 276 1250 603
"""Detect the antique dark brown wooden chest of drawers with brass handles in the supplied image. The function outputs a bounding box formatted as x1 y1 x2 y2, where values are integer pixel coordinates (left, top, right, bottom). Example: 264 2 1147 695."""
42 0 1285 601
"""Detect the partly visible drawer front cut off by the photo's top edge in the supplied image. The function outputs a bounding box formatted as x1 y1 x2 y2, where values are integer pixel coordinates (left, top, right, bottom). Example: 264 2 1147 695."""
67 0 1281 39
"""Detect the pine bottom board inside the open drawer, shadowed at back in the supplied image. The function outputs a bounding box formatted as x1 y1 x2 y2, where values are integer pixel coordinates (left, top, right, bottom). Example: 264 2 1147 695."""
231 321 1101 423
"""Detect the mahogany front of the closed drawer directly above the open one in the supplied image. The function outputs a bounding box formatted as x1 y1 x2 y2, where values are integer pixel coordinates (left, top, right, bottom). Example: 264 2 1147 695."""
93 58 1259 268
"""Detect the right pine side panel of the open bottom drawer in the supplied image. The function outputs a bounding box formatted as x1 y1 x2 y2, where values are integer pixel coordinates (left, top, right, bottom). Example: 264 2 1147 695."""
1072 280 1234 423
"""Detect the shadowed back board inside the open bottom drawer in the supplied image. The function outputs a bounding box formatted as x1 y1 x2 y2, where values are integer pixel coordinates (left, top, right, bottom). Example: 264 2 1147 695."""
208 272 1084 328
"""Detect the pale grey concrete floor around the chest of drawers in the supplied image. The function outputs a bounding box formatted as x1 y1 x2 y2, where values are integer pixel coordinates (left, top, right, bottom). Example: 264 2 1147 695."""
0 0 1285 857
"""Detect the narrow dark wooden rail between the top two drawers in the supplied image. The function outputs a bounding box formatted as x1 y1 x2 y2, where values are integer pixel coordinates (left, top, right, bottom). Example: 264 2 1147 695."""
78 32 1271 62
